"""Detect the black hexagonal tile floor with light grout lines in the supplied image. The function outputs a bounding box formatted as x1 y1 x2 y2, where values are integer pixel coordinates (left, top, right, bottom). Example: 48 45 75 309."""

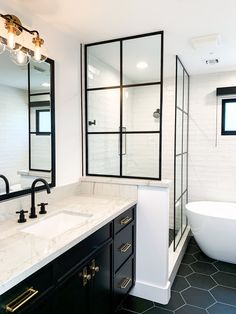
118 238 236 314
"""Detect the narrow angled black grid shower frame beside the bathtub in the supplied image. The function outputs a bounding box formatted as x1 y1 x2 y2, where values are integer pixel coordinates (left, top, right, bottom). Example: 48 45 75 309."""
173 56 190 251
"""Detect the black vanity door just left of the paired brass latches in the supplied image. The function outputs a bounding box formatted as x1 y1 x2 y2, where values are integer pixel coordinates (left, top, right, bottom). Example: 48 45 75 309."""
53 268 88 314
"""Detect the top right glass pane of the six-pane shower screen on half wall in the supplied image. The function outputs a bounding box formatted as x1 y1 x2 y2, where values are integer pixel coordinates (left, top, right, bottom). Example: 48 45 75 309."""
123 35 162 85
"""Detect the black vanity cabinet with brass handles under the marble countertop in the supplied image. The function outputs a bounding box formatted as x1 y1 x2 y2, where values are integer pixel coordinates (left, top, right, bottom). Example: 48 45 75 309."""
0 206 135 314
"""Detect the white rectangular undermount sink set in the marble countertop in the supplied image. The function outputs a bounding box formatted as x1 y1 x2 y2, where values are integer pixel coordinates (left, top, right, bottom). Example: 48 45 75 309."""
21 211 92 239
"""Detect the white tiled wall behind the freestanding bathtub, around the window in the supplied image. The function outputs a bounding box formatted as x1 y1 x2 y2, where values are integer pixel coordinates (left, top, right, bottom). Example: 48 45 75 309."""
189 72 236 202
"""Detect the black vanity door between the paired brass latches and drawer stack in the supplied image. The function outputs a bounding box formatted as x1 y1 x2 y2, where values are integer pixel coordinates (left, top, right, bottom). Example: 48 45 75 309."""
89 244 112 314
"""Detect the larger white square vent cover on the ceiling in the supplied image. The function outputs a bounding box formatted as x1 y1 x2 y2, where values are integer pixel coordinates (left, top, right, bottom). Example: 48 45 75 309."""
190 34 221 51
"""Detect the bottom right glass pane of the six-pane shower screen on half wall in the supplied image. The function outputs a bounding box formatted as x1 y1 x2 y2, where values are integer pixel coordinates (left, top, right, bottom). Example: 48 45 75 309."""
122 134 159 177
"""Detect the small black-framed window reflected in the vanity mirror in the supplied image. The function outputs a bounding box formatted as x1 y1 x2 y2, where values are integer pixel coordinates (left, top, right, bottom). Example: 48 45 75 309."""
36 109 51 135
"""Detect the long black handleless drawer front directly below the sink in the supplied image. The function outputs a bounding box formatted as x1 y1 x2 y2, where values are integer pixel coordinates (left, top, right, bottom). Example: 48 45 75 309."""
54 224 112 281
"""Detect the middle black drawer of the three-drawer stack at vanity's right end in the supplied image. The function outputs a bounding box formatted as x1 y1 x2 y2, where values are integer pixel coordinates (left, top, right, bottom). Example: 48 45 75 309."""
114 224 134 271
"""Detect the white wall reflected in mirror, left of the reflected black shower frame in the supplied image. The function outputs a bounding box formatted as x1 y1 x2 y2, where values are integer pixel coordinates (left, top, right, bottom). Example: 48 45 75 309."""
0 85 29 188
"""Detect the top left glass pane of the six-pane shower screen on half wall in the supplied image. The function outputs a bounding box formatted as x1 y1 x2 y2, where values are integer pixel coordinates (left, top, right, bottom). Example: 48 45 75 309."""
86 42 120 88
